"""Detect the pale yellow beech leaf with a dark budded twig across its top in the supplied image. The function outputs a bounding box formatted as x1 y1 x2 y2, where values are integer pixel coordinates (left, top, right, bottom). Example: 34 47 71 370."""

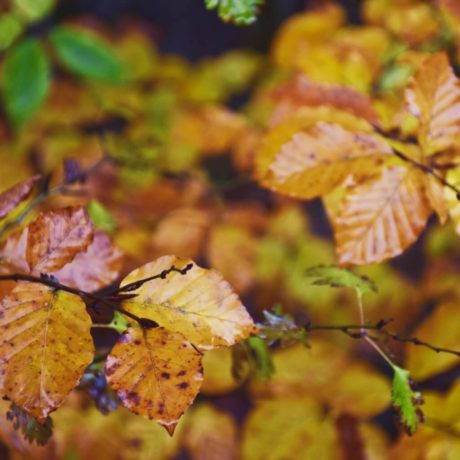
121 256 255 349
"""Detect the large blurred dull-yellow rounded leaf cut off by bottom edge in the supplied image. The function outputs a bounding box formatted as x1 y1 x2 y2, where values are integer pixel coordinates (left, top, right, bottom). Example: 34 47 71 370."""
242 397 338 460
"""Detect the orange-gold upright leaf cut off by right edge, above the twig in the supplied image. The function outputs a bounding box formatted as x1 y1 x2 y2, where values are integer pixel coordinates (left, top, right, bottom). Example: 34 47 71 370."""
406 53 460 155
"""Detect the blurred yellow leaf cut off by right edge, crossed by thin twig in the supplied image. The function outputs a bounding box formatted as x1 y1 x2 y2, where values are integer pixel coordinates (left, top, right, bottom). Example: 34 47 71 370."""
407 301 460 380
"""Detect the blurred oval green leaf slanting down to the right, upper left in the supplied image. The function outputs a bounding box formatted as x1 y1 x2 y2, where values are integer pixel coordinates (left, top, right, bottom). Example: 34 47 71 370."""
50 26 125 83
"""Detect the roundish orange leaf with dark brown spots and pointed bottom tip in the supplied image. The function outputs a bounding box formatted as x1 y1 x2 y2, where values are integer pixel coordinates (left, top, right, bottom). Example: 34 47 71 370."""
105 328 203 435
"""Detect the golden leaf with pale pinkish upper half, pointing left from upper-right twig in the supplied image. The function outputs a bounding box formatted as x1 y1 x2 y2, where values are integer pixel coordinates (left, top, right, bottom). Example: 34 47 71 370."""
256 117 392 199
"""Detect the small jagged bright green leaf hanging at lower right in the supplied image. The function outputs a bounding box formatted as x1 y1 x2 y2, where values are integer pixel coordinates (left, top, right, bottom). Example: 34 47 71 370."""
391 365 423 435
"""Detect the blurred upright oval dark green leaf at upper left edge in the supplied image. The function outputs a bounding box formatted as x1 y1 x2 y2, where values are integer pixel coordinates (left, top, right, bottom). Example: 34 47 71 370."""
2 39 50 128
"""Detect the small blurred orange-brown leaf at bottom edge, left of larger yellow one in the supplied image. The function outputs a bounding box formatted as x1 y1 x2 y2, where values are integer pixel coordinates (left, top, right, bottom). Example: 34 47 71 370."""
184 404 239 460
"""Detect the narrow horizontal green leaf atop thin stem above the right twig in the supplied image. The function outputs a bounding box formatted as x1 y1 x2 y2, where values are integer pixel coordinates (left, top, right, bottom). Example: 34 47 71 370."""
305 266 377 295
